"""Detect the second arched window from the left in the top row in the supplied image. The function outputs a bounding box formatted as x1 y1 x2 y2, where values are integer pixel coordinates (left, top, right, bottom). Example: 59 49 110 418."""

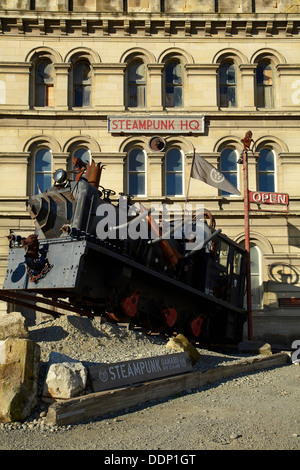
73 60 92 108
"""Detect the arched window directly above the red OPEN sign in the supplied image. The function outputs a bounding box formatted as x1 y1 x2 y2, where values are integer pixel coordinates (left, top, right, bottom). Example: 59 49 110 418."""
257 148 276 192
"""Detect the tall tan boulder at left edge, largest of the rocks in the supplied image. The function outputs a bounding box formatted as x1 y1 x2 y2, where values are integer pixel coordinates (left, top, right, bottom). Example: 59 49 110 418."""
0 338 40 423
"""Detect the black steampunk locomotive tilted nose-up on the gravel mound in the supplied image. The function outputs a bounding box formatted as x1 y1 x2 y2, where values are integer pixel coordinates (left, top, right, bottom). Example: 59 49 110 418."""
0 161 247 344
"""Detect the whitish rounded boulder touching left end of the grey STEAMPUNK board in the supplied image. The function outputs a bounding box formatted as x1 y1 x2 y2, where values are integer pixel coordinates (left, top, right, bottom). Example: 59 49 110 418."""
42 362 87 401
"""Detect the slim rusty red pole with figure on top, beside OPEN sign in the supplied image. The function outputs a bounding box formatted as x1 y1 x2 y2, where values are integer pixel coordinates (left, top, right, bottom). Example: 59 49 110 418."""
238 131 254 340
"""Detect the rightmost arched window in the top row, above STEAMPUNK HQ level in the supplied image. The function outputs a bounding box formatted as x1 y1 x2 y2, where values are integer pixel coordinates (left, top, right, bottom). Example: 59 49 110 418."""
256 60 273 108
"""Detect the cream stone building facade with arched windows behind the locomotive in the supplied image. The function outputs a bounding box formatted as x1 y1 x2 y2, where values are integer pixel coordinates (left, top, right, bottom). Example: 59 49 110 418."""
0 0 300 344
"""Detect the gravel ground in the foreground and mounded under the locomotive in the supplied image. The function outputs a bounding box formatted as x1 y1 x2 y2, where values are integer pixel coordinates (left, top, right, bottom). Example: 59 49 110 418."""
0 315 300 454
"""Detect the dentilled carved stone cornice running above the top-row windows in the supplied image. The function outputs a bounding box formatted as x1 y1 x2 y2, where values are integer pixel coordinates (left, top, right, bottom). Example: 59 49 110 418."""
0 10 300 40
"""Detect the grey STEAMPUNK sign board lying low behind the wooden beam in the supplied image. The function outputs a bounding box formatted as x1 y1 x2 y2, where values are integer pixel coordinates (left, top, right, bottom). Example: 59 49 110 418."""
88 352 193 392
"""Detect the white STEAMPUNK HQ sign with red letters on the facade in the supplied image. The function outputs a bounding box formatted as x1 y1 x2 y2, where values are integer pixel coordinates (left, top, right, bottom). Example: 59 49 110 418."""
107 115 204 134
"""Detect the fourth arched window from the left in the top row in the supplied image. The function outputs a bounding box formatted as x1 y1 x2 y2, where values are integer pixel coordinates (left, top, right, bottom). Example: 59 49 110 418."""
165 59 183 108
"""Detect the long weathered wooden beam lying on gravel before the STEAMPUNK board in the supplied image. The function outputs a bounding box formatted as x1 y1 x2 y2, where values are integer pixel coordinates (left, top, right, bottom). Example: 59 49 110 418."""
46 353 290 425
